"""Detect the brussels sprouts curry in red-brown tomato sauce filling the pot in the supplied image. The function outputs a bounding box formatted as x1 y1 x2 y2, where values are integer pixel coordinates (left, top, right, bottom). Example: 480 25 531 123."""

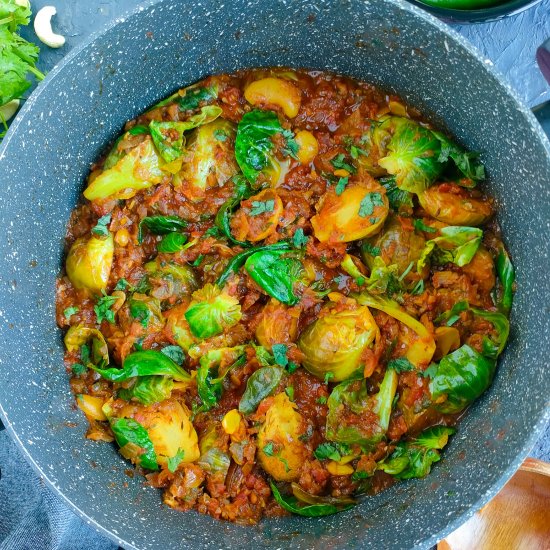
57 69 514 524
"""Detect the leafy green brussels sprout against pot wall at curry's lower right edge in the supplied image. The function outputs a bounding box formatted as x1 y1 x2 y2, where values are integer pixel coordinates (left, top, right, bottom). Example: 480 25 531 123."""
377 426 456 479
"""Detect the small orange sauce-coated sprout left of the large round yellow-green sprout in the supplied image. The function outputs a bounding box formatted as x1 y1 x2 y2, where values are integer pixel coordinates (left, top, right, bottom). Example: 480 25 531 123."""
256 300 300 350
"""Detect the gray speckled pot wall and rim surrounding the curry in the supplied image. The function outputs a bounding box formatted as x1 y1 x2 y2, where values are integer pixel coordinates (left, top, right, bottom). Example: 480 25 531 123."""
0 0 550 550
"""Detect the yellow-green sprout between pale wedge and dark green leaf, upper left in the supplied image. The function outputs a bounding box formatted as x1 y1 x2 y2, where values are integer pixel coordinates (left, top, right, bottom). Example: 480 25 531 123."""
174 119 238 201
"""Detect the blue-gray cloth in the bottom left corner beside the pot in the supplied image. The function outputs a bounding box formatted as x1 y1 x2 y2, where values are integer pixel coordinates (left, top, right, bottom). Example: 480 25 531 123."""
0 431 118 550
